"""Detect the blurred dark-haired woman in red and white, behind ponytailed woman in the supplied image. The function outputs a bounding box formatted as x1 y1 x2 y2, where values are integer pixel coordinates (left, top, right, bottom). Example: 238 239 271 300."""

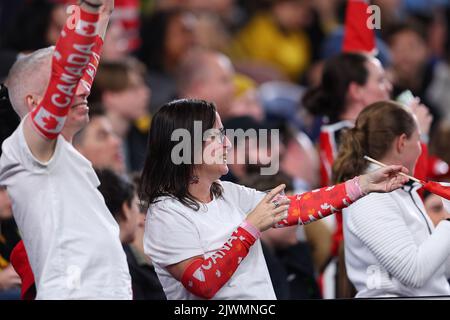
303 53 392 186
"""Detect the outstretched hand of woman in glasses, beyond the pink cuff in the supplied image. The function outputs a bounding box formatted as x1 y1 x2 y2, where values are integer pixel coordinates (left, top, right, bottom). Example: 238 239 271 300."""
359 165 409 194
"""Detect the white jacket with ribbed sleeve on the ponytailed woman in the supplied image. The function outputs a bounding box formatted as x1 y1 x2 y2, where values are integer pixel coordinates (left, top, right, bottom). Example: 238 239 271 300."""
343 178 450 297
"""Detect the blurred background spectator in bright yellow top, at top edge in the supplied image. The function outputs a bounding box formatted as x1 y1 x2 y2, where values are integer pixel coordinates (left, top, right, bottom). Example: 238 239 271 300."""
232 0 312 81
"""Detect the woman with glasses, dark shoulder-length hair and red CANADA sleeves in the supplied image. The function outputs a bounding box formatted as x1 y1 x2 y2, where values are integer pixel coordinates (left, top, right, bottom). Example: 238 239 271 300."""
141 99 406 299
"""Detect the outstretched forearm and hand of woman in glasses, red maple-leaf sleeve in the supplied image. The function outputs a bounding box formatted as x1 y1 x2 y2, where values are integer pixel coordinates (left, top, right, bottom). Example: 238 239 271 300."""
274 166 408 228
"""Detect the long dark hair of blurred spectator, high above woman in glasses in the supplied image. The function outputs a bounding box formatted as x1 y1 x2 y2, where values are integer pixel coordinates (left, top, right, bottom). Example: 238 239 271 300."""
138 8 185 72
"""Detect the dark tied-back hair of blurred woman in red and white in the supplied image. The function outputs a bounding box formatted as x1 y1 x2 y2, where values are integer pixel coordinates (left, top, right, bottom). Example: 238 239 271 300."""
302 53 369 122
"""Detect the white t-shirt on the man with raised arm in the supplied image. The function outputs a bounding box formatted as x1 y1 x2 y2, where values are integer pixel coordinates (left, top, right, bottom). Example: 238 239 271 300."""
0 121 132 299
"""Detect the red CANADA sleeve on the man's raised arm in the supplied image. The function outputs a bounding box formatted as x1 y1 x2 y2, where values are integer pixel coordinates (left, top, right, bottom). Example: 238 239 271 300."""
31 8 99 139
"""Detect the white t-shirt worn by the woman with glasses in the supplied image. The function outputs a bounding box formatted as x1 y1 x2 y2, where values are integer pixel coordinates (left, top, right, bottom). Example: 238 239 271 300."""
144 182 276 300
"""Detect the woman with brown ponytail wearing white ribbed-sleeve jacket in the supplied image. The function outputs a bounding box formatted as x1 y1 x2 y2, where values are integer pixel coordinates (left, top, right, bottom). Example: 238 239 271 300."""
333 101 450 297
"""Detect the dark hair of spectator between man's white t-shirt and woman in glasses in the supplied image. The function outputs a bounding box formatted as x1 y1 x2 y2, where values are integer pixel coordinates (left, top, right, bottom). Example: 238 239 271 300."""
95 169 135 220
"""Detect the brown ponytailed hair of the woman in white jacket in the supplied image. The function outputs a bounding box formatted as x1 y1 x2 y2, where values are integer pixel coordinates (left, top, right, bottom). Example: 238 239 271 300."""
333 101 417 183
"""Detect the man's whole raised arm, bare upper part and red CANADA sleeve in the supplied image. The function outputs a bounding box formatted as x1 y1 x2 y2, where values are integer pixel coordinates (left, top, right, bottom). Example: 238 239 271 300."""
24 0 105 161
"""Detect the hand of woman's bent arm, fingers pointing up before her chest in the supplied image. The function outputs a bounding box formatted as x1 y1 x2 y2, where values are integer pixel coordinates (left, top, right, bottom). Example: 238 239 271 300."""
246 184 290 231
